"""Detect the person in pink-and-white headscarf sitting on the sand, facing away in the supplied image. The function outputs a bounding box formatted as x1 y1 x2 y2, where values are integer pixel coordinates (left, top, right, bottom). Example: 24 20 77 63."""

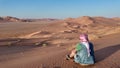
66 34 95 65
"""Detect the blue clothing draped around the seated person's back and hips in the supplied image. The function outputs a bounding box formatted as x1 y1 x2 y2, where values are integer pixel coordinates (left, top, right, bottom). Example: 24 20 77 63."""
74 43 95 64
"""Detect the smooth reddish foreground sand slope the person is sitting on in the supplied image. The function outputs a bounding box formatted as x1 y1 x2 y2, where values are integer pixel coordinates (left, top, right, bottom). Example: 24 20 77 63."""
0 34 120 68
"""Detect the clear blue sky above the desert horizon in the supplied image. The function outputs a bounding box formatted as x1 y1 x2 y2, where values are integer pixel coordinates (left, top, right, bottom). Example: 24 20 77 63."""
0 0 120 18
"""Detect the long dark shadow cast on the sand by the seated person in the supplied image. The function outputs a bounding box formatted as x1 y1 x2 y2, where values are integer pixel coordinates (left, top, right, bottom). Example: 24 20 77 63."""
95 44 120 62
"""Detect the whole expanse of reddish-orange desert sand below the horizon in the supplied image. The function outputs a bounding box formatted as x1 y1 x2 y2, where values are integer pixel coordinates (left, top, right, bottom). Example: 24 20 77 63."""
0 17 120 68
